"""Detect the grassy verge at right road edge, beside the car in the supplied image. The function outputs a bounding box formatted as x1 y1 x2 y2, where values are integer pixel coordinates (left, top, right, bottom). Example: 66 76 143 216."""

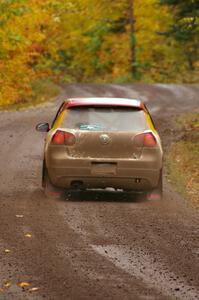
166 112 199 208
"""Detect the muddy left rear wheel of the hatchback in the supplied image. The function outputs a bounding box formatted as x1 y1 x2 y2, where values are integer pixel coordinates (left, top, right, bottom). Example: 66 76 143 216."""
42 164 66 199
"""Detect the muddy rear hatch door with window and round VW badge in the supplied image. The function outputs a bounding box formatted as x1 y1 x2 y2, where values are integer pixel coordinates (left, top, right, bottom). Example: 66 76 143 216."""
62 106 147 161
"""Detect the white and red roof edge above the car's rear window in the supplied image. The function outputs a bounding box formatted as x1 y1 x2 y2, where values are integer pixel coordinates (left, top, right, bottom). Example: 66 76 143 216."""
66 97 144 109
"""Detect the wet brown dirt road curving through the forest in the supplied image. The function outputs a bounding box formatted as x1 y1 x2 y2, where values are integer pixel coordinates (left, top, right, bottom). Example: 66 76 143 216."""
0 85 199 300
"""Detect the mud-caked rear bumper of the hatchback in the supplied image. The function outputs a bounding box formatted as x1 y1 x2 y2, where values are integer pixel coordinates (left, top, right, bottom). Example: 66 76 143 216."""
46 158 162 191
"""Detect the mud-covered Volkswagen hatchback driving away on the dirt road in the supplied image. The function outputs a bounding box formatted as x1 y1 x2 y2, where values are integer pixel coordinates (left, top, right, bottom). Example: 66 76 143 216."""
36 98 163 199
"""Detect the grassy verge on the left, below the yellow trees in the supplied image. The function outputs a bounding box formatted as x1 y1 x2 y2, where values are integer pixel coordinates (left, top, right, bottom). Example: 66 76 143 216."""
0 78 61 111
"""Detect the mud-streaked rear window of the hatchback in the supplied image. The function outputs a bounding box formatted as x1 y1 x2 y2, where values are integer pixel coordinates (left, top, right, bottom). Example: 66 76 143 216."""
62 106 147 131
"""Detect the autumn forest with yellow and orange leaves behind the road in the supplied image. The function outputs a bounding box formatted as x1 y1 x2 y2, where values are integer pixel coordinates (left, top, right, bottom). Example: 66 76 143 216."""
0 0 199 106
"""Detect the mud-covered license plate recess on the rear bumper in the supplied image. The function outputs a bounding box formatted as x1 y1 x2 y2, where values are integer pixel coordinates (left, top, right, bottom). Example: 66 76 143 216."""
91 162 117 175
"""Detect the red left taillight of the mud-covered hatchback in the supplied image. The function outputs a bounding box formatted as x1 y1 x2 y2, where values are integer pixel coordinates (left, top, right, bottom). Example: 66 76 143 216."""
51 130 76 146
